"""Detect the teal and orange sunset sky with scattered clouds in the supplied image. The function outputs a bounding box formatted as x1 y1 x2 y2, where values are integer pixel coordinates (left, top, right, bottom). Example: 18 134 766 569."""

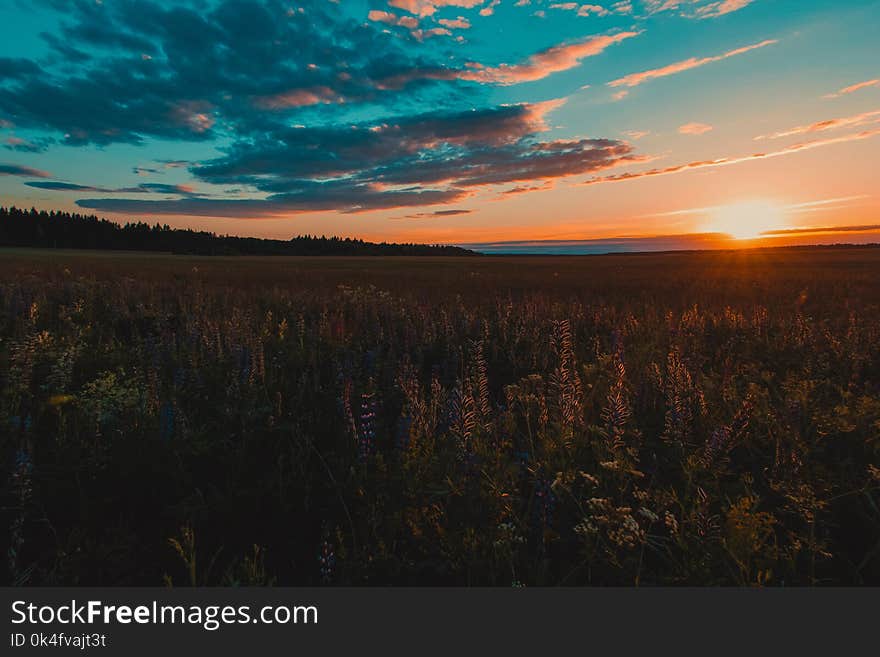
0 0 880 253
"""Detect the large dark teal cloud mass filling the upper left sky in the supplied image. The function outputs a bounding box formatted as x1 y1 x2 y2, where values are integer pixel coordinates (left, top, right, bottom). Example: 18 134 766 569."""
0 0 472 145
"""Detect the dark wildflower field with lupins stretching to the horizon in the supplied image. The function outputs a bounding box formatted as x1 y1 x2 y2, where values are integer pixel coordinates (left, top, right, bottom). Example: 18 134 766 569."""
0 248 880 586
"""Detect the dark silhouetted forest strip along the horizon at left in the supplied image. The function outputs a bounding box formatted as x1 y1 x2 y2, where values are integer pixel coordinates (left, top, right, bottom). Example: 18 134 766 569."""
0 207 477 256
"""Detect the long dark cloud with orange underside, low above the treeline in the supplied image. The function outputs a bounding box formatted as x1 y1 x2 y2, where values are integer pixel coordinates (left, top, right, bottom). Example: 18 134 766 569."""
78 100 640 217
